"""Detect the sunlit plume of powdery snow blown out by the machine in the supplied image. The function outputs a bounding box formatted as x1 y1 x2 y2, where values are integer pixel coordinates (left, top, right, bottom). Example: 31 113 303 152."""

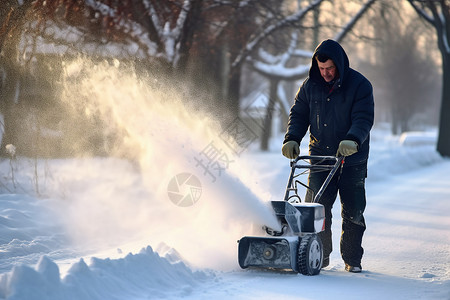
51 59 278 269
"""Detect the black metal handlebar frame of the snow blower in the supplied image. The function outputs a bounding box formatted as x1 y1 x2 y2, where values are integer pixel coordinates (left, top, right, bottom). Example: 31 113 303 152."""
284 155 344 203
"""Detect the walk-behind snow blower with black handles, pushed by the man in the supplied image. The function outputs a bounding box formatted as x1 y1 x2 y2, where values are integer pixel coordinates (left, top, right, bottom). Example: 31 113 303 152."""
238 156 344 275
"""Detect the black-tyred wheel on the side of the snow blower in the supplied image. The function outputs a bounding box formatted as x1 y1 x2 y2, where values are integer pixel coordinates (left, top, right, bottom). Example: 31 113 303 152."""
298 234 323 276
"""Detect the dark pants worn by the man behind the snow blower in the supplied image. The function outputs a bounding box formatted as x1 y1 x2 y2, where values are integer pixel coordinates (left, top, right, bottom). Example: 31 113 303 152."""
306 163 367 266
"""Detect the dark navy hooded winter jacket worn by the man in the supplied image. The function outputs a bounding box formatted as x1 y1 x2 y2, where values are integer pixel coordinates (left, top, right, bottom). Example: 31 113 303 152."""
284 40 374 165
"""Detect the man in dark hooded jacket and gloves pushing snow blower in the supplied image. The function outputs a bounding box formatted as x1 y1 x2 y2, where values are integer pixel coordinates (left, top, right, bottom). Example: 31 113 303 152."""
282 40 374 273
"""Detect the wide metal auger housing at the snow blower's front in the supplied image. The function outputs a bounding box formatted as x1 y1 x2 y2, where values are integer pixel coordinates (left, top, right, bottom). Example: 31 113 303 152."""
238 236 299 272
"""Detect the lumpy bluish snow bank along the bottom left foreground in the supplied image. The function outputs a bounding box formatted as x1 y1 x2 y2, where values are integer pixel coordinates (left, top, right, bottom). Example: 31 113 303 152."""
0 247 207 300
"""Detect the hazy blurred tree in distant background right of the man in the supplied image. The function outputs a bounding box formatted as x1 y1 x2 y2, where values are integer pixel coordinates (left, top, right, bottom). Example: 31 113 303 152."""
366 3 440 134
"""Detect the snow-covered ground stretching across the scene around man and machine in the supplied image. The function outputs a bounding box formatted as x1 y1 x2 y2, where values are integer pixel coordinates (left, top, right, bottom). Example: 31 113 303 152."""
0 129 450 300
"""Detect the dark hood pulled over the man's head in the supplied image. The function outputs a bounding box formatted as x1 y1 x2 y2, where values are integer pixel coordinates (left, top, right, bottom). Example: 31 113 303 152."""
309 40 349 83
